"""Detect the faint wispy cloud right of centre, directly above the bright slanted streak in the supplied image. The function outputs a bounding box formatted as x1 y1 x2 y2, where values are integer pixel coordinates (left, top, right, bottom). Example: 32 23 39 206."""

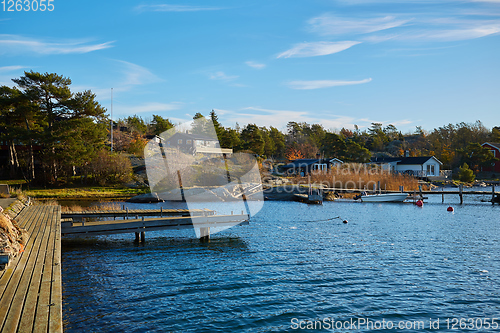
308 14 411 35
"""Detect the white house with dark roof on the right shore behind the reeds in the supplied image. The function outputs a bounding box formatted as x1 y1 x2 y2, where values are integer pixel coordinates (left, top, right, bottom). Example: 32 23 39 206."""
370 156 443 177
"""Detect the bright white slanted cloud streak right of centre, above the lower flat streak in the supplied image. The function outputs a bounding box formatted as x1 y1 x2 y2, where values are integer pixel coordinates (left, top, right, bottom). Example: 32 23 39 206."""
276 41 360 58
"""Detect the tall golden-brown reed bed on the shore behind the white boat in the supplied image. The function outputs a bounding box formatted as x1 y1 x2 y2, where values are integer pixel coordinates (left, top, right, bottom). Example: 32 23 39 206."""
293 163 425 191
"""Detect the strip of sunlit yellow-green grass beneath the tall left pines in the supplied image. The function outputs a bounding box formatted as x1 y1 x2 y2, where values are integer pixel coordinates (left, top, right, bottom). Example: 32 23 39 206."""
0 180 149 199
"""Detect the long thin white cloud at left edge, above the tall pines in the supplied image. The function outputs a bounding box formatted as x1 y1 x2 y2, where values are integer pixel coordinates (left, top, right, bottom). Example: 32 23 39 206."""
0 35 113 55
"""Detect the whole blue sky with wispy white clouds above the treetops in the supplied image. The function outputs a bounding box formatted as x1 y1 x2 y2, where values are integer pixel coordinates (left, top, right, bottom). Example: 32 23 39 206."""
0 0 500 132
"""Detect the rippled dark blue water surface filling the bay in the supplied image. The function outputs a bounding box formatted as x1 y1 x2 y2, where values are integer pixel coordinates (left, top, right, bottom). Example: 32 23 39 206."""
62 196 500 332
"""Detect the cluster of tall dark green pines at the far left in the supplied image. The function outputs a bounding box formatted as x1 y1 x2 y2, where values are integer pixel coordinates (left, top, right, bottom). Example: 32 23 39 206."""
0 71 132 185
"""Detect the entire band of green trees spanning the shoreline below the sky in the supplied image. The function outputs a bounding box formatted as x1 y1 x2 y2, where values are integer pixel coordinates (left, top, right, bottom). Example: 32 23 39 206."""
0 71 500 184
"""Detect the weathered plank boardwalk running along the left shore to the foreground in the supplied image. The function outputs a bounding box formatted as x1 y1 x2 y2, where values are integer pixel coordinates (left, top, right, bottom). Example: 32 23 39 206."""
0 206 63 333
